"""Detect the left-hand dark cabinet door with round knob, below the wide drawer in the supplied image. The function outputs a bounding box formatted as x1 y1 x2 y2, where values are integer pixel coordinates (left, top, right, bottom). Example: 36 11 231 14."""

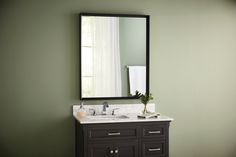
88 143 114 157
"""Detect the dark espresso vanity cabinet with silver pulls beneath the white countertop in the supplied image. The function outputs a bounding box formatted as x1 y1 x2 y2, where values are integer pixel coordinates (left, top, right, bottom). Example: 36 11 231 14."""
76 121 170 157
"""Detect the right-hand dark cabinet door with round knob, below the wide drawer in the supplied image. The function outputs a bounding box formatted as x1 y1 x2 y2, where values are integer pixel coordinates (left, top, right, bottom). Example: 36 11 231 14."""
114 141 138 157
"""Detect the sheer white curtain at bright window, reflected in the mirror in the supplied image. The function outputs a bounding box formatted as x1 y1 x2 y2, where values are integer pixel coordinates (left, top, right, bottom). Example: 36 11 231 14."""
82 17 121 97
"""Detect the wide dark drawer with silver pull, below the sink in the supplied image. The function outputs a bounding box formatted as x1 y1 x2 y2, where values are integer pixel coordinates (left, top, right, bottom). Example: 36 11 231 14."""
88 126 138 140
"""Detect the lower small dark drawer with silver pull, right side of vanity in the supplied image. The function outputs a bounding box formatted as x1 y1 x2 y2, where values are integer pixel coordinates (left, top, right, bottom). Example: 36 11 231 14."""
142 141 166 157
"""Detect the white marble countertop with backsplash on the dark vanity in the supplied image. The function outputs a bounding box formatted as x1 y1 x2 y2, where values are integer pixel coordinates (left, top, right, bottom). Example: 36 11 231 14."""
73 103 174 124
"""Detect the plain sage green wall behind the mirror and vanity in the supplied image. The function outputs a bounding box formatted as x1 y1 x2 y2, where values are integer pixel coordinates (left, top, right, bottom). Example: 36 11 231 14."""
0 0 236 157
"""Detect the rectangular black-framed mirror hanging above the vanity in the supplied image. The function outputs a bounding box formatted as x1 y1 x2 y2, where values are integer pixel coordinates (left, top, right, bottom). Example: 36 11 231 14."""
79 13 150 100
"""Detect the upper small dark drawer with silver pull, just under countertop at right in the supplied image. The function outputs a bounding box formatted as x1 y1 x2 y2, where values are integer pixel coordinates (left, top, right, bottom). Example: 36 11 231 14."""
142 125 167 138
